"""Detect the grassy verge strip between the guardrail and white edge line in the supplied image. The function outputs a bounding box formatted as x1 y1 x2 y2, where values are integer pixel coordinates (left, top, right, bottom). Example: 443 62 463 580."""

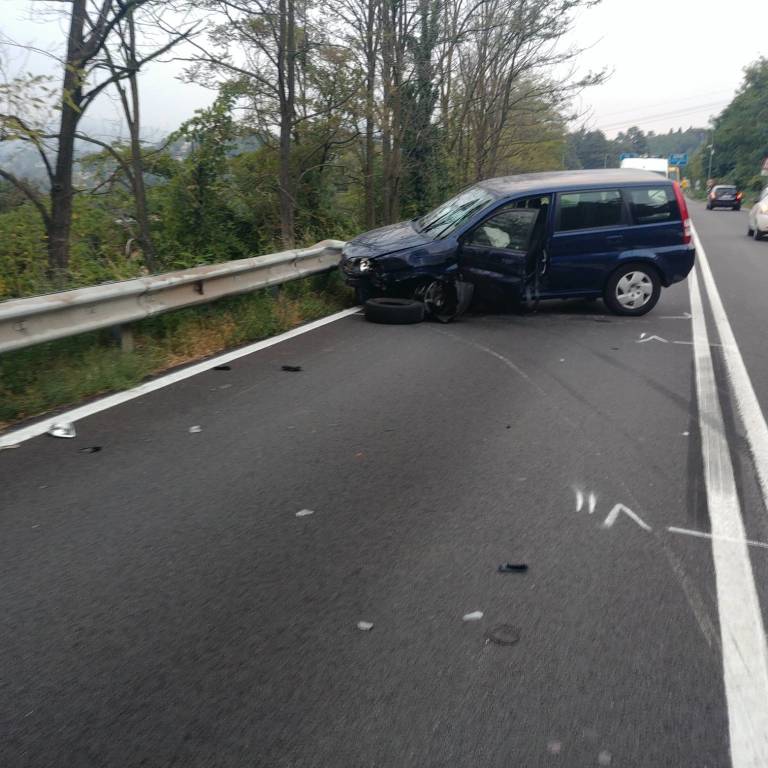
0 273 354 427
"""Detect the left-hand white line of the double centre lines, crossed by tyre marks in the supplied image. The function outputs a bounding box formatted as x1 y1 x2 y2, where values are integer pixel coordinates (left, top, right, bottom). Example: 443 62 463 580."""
688 270 768 768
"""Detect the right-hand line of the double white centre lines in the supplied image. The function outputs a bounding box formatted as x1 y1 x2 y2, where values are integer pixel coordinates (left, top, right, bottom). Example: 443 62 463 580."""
693 229 768 520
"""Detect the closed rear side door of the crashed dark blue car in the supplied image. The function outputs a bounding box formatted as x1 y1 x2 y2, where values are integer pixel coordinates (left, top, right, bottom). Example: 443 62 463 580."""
542 187 628 296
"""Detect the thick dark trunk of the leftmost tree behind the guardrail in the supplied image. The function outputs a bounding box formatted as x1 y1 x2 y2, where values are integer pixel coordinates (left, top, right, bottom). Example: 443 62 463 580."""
48 0 86 284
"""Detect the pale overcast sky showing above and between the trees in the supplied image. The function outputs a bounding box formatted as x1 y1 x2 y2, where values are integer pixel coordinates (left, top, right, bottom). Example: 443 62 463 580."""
0 0 768 136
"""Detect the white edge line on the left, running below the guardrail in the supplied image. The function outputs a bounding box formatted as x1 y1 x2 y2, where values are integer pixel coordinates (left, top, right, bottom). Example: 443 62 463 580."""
0 307 360 448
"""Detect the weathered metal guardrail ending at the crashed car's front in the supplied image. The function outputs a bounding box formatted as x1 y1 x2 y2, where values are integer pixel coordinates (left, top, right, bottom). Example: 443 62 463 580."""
0 240 344 353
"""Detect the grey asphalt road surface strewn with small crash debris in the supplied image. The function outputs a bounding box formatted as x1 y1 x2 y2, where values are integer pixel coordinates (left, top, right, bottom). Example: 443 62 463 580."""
0 204 768 768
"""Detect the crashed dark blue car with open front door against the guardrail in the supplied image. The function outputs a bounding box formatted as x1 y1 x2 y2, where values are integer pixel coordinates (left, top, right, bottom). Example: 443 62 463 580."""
340 169 694 320
